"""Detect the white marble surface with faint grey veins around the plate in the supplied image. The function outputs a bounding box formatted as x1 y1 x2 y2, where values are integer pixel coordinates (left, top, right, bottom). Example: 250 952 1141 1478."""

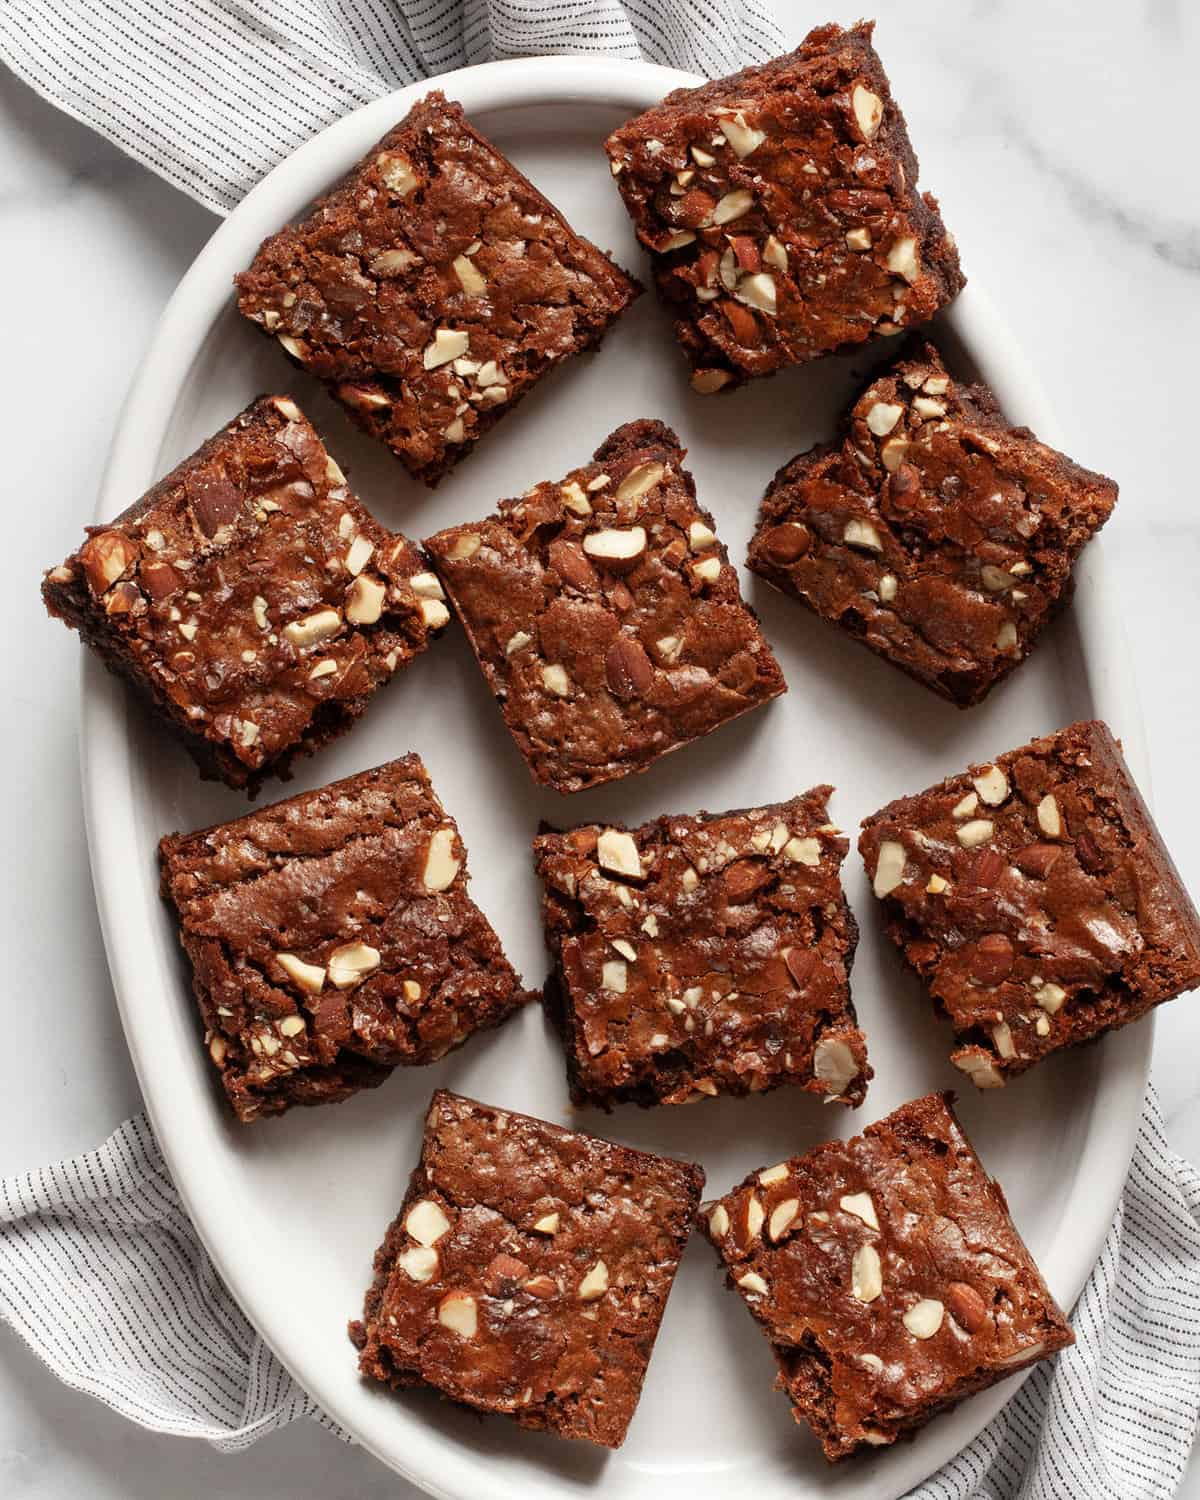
0 0 1200 1500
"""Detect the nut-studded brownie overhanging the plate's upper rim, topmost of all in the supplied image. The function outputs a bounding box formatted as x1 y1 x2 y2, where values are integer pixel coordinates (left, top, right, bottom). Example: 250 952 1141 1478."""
606 23 963 395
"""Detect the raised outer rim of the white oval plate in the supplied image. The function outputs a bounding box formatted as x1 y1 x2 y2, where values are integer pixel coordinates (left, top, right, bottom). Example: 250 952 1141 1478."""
80 56 1154 1500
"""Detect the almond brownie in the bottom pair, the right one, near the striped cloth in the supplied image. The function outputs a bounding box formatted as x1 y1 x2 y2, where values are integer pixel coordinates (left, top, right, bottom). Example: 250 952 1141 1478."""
701 1094 1074 1460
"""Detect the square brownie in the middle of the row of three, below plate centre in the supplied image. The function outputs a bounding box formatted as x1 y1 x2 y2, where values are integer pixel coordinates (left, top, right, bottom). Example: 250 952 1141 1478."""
534 786 872 1107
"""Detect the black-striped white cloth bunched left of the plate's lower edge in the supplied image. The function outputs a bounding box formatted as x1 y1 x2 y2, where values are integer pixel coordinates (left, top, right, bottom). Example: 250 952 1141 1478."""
0 1116 333 1451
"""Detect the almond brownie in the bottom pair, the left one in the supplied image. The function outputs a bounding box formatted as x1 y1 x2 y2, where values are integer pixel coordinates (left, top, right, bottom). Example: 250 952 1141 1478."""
350 1089 704 1448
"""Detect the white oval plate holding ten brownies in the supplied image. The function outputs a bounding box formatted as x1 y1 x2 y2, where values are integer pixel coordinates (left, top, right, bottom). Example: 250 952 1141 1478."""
83 59 1151 1500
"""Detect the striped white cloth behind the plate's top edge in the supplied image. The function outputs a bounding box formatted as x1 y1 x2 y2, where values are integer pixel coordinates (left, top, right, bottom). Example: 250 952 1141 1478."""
0 0 783 213
